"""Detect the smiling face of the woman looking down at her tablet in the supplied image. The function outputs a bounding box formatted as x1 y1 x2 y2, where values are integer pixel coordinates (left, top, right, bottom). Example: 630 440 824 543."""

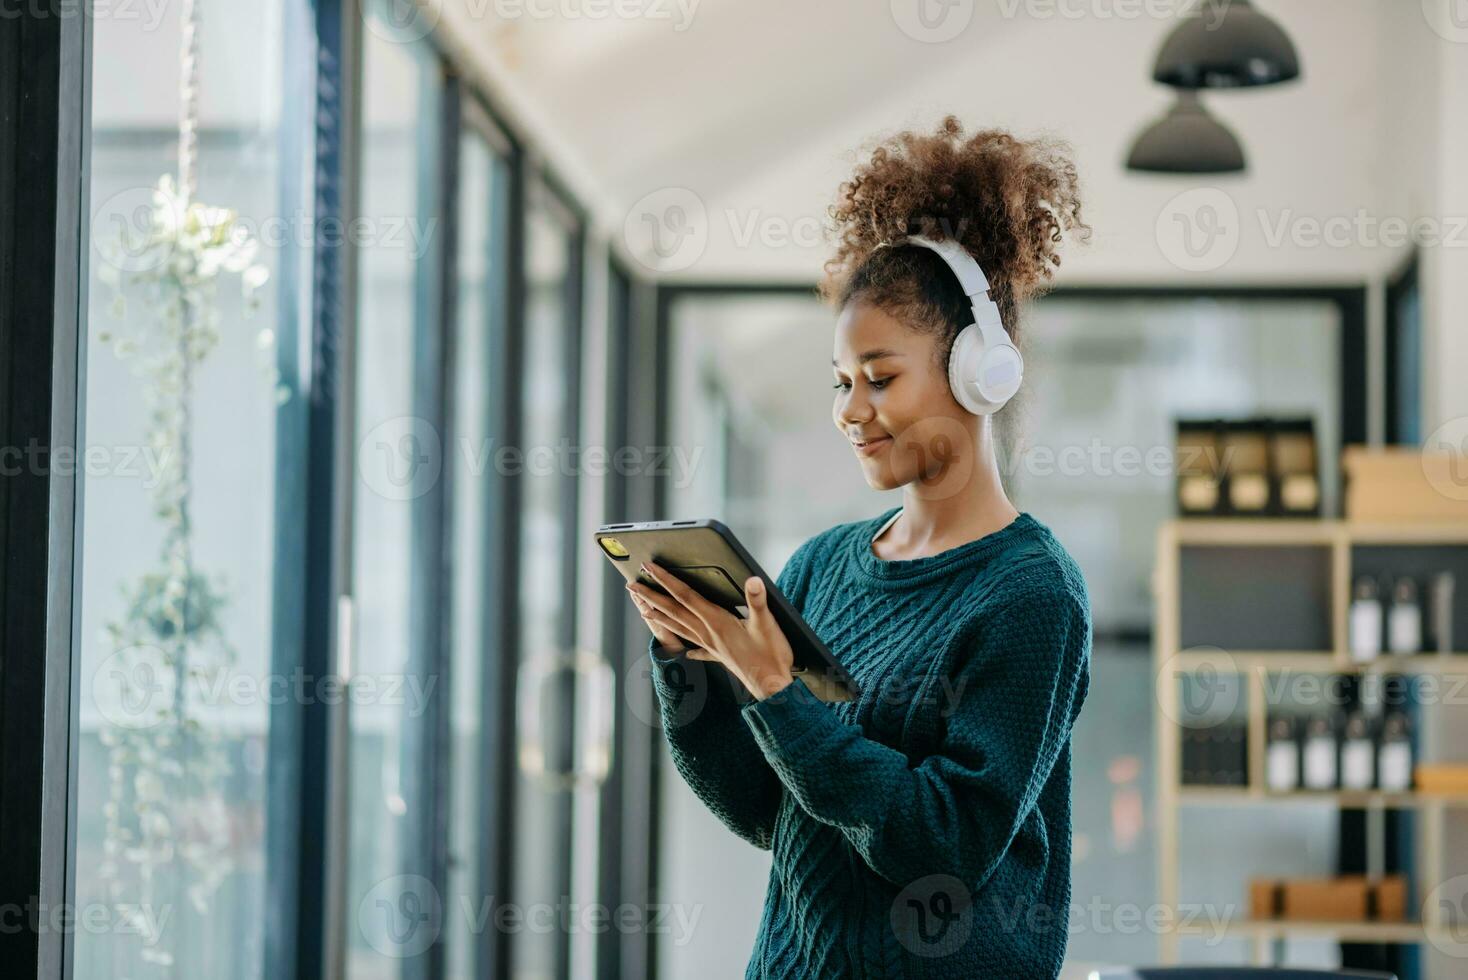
831 301 978 490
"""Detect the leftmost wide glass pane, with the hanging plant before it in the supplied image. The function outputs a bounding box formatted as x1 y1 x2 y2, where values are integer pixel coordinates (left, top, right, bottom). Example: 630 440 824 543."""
70 0 311 980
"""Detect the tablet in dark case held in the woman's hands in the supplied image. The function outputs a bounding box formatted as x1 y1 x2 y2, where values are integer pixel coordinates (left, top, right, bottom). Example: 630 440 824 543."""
596 518 860 701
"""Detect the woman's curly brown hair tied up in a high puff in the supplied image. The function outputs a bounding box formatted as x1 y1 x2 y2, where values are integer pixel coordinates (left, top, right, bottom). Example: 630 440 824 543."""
819 116 1091 370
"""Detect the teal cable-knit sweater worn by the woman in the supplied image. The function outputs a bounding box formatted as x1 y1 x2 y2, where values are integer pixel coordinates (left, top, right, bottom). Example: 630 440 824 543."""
649 508 1091 980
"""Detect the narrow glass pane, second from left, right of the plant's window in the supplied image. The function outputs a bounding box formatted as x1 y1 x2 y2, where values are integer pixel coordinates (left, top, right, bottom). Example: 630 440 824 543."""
344 25 443 979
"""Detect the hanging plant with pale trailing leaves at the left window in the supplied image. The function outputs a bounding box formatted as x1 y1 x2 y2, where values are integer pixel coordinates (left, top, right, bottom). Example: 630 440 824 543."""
89 0 279 965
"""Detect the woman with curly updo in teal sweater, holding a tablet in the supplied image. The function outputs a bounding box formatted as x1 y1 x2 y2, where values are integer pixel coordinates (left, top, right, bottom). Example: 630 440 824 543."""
628 116 1091 979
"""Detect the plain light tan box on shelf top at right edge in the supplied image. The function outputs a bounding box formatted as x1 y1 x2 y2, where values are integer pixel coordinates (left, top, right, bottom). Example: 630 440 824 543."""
1340 446 1468 521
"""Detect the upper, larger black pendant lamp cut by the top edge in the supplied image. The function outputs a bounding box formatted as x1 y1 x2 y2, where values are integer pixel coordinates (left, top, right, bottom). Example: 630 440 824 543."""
1152 0 1299 88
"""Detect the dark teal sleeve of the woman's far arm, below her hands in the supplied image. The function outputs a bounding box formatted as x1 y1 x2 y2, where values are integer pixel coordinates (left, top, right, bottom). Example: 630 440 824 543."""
647 541 809 851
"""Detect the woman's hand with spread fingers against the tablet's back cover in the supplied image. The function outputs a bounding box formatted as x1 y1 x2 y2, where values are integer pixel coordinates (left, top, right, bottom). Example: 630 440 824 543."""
627 562 794 701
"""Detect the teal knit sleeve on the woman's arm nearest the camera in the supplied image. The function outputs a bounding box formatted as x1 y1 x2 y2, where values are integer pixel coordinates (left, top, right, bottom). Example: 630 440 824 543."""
743 580 1091 891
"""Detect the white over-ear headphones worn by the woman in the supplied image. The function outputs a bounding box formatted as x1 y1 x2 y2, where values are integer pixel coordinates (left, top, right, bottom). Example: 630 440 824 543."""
878 235 1025 415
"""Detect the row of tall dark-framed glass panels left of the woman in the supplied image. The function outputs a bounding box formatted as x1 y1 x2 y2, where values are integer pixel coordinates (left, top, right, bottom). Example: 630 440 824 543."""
68 0 599 979
